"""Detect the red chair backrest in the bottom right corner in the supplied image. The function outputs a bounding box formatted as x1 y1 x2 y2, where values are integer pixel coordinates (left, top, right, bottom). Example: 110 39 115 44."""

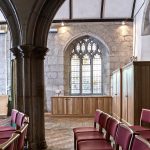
131 135 150 150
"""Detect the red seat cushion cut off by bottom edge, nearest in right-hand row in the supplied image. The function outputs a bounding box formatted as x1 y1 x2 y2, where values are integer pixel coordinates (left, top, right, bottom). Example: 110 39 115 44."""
78 140 113 150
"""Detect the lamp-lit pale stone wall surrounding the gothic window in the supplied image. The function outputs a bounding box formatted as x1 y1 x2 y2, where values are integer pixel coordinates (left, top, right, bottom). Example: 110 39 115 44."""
45 22 133 111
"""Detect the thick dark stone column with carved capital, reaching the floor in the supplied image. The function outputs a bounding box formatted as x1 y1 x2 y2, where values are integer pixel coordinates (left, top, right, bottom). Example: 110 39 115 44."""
20 45 48 150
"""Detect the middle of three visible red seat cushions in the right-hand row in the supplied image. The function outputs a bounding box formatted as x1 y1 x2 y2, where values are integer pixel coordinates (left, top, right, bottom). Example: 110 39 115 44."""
76 131 105 142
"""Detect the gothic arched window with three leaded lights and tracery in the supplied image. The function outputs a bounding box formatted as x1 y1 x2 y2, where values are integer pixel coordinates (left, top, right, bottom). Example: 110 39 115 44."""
70 37 102 95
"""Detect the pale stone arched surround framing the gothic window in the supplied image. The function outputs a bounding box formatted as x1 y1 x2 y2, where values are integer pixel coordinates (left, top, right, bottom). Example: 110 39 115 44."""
64 33 110 95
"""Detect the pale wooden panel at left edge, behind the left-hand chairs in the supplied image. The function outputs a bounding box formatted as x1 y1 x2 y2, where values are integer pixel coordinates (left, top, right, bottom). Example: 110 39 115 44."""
0 95 8 116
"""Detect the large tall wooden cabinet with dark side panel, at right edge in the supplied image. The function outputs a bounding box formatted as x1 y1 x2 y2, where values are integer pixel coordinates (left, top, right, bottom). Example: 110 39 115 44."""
122 61 150 125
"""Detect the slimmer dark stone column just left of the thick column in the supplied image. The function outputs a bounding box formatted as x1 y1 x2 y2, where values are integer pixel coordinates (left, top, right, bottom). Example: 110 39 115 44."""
10 47 25 112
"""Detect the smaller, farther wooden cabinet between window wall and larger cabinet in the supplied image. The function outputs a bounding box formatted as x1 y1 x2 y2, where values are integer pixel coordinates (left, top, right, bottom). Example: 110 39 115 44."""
111 69 122 120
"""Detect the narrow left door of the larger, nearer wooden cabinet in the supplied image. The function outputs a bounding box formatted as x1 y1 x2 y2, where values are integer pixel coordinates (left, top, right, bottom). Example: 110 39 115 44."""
122 68 128 122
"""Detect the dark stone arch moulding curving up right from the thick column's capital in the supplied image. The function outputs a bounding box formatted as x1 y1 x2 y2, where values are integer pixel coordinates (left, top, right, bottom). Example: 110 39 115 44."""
34 0 65 47
